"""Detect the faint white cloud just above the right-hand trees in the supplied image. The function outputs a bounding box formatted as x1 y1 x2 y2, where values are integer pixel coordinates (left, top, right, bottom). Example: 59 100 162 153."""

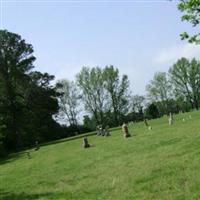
154 43 200 64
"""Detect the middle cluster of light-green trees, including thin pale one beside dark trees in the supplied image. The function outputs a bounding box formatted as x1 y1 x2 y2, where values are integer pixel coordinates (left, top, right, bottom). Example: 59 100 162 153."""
56 66 130 129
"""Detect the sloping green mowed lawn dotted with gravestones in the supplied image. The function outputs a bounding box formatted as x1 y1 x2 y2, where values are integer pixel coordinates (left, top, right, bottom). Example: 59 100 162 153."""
0 112 200 200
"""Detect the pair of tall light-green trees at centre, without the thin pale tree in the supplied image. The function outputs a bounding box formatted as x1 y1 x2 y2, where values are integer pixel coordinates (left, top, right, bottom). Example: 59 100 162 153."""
77 66 129 126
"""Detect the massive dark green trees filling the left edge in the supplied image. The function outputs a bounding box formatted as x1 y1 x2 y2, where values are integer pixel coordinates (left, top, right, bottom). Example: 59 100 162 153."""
0 30 60 151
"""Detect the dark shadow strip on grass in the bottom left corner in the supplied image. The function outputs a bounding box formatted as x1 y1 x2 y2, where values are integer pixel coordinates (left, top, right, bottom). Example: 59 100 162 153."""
0 192 54 200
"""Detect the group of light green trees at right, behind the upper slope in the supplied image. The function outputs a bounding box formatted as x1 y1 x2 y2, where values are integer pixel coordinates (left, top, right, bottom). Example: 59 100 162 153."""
146 58 200 115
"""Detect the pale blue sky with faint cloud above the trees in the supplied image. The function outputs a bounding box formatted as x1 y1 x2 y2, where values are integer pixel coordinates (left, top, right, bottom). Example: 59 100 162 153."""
0 0 200 95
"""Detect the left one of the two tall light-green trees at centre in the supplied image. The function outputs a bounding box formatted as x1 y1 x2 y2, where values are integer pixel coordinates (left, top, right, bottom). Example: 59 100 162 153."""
77 67 107 124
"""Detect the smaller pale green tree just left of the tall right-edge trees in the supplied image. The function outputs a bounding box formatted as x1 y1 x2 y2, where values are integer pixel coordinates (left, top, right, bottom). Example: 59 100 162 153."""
146 72 172 114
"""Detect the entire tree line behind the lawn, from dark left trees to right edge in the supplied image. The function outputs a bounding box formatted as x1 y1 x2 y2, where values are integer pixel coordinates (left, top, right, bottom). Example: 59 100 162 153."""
0 30 200 154
